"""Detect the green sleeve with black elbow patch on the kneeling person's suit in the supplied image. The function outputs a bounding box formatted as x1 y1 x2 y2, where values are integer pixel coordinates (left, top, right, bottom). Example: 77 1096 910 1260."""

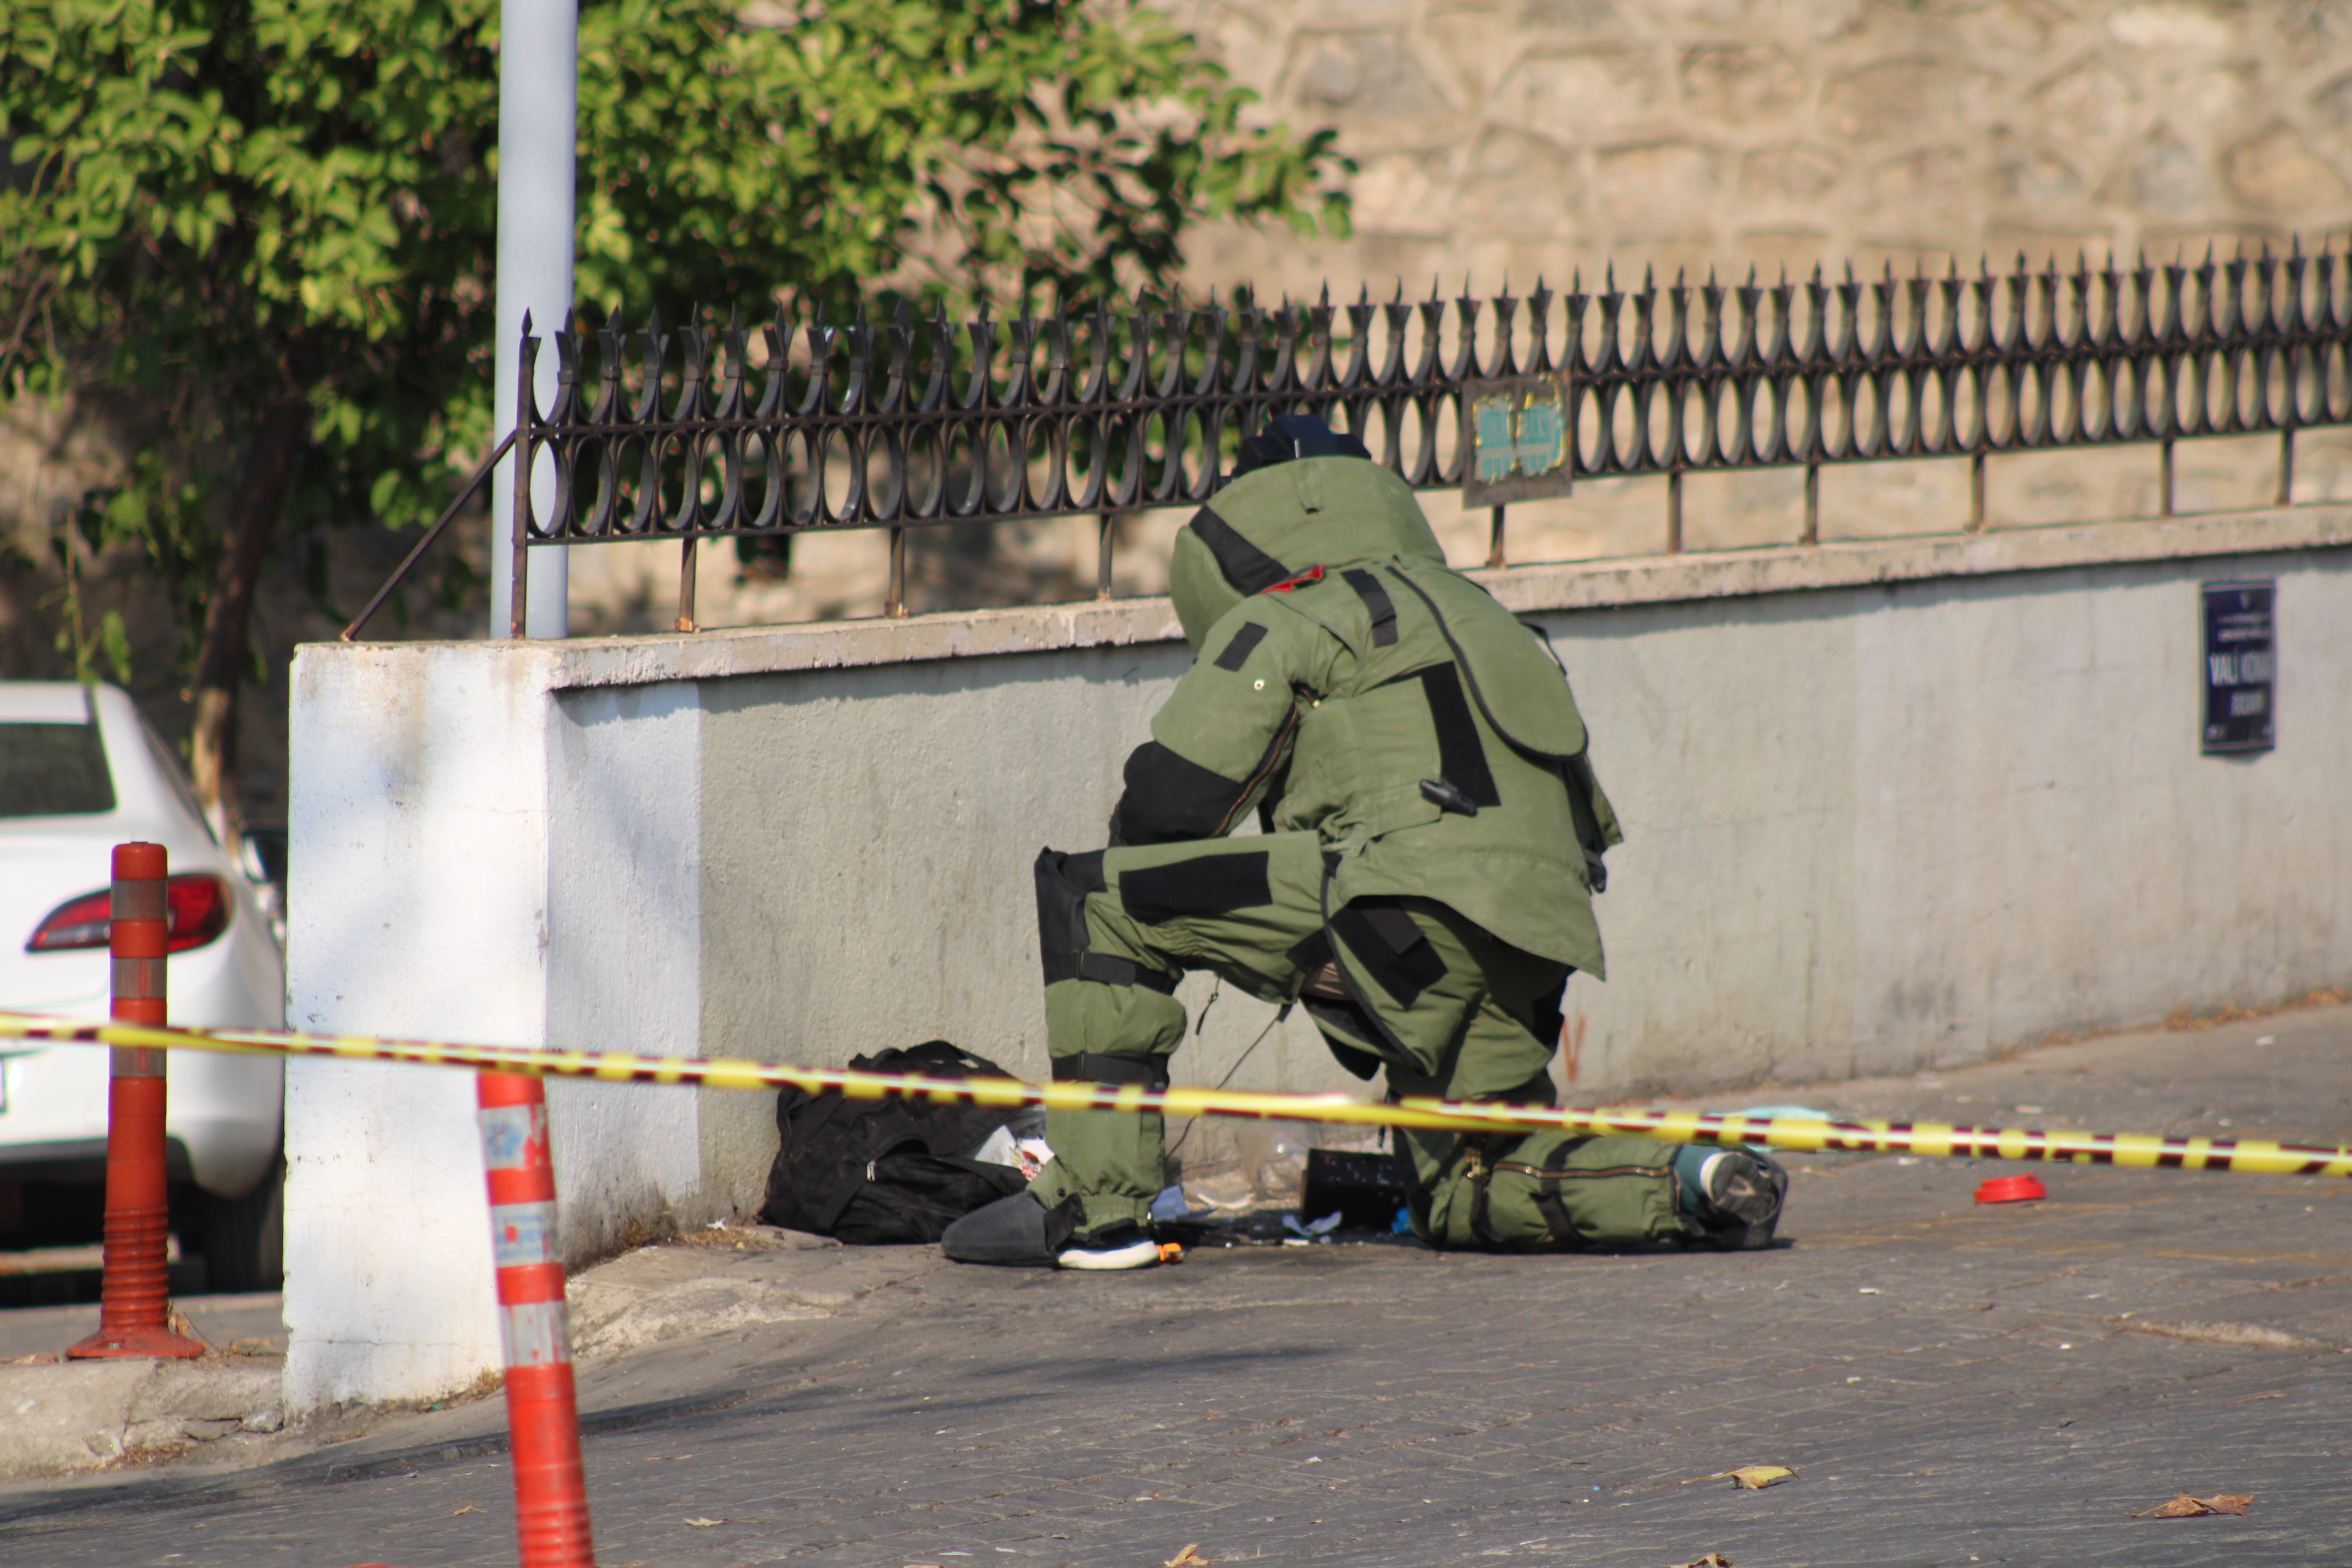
1110 597 1329 844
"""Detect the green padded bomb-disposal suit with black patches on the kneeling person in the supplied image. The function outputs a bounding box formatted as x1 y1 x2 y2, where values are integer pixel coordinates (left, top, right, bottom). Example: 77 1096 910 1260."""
1030 456 1691 1248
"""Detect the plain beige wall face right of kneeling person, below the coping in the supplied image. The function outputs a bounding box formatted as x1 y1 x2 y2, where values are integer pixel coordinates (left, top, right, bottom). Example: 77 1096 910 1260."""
1547 550 2352 1089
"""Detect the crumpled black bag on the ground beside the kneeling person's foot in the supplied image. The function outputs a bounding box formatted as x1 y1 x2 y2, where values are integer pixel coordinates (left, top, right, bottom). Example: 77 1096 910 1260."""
760 1039 1028 1246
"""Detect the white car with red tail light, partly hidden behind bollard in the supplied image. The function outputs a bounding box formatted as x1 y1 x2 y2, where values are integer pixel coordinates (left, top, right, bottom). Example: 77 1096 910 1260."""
0 682 285 1291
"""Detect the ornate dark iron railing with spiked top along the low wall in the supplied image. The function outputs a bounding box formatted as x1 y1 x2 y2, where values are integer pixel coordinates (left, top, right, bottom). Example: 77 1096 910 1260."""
336 244 2352 628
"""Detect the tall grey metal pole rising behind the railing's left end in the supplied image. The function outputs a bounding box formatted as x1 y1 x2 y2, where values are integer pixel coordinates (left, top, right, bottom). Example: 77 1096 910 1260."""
489 0 579 637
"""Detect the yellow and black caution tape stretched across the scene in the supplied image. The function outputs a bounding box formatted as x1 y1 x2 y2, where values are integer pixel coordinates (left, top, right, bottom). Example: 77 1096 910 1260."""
14 1013 2352 1175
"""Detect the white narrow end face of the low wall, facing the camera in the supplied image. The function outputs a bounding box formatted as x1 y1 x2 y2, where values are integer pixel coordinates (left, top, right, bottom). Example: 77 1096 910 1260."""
285 644 550 1408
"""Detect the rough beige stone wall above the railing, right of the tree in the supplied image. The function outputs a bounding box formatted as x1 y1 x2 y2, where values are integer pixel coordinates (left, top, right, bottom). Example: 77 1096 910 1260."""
1176 0 2352 296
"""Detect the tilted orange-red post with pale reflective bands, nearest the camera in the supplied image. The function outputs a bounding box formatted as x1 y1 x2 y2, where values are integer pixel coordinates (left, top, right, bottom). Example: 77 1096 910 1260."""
475 1072 595 1568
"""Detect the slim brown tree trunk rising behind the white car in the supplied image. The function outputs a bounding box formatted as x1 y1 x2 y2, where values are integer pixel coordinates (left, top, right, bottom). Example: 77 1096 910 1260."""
188 397 311 849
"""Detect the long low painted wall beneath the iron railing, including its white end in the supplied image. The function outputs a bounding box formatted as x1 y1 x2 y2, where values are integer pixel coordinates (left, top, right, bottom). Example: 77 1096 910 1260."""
287 508 2352 1408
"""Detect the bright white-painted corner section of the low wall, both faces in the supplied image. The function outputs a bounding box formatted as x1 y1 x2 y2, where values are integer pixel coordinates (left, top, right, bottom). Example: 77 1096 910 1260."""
285 642 741 1408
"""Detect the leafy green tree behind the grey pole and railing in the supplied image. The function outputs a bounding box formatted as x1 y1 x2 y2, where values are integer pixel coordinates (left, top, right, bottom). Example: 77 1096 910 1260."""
0 0 1345 827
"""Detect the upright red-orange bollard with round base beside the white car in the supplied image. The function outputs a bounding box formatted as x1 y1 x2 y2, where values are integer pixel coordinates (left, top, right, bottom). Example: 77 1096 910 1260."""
66 844 205 1361
